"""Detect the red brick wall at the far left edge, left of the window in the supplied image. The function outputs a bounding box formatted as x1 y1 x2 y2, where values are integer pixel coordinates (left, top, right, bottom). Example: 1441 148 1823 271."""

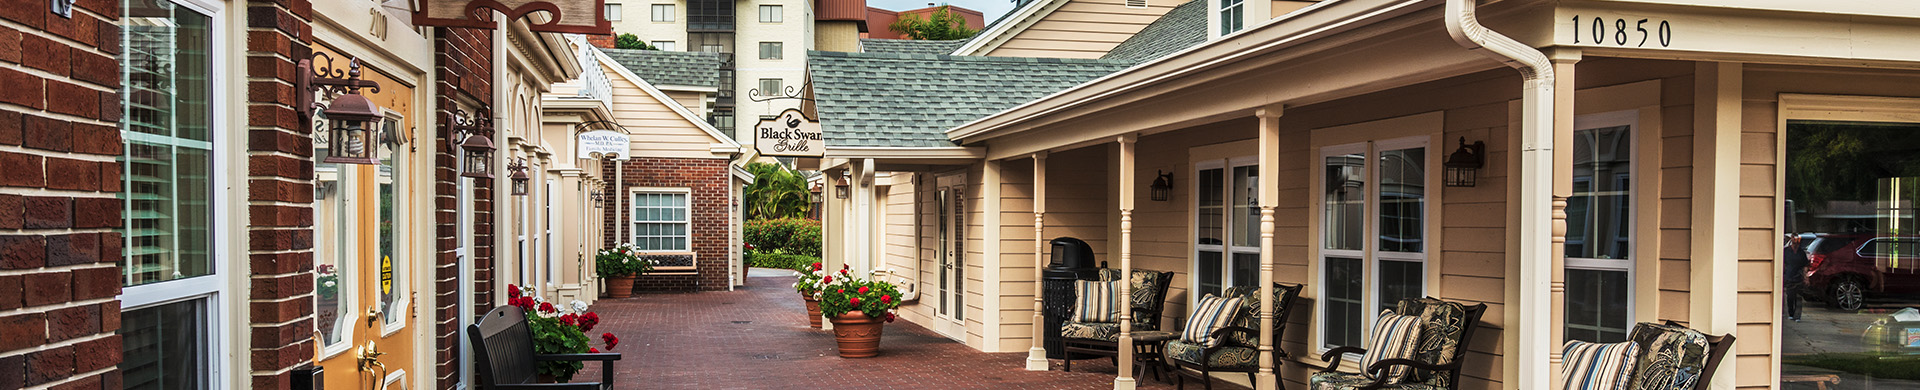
0 0 123 388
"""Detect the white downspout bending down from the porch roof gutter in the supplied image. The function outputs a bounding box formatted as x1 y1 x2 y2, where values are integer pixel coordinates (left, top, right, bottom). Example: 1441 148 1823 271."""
1442 0 1553 388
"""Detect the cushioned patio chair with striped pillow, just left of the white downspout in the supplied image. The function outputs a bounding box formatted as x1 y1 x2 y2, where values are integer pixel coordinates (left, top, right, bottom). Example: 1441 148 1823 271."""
1308 298 1486 390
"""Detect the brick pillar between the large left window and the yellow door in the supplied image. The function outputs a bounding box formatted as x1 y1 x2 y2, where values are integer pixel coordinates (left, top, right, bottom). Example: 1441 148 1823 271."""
245 0 313 388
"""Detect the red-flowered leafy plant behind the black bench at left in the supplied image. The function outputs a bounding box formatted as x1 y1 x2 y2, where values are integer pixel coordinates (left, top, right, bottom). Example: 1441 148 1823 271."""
507 284 620 382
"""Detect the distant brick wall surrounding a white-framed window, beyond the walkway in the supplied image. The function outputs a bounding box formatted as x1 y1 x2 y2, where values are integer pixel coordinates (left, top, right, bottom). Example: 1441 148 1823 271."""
601 158 735 290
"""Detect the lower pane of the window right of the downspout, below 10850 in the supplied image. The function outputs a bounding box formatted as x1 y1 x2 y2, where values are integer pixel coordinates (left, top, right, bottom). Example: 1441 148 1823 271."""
1567 269 1630 342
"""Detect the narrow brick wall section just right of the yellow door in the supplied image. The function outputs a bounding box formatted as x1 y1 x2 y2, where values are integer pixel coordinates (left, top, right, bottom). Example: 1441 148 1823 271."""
434 29 503 390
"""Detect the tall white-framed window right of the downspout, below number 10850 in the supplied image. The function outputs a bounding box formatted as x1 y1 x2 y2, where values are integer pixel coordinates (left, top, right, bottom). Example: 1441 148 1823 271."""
1565 111 1638 342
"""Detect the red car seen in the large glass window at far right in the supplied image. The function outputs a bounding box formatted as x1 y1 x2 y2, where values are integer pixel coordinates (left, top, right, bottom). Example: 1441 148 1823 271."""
1807 234 1920 311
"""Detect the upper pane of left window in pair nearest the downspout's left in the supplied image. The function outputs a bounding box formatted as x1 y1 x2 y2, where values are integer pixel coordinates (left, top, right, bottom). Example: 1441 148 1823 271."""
1323 154 1367 250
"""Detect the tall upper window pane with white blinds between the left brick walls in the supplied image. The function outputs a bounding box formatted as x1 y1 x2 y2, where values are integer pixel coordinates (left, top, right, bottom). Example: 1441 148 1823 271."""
119 2 215 286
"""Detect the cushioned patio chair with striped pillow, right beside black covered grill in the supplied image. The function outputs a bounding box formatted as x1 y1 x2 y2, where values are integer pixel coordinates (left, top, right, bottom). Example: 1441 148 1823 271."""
1060 269 1173 371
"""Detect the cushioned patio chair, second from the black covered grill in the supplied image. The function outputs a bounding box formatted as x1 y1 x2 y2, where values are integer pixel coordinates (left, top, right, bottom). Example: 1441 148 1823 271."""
1165 282 1306 388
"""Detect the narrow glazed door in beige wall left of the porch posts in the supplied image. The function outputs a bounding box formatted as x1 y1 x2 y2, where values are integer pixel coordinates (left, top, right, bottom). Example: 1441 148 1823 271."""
933 173 966 338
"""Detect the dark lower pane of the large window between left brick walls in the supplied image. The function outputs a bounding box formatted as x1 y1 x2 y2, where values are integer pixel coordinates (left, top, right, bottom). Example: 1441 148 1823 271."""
119 300 213 390
